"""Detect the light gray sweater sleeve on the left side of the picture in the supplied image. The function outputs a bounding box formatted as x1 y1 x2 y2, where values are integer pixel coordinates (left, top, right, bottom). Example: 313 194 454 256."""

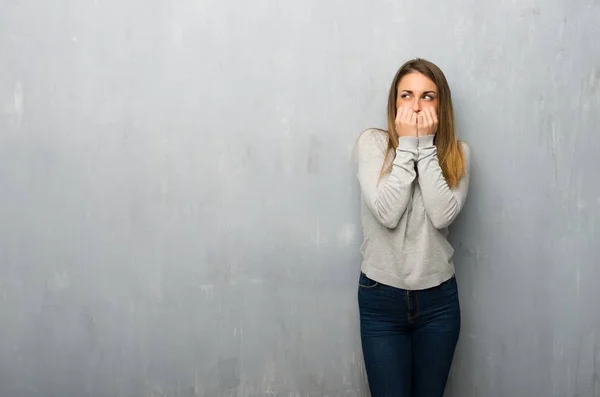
357 130 418 229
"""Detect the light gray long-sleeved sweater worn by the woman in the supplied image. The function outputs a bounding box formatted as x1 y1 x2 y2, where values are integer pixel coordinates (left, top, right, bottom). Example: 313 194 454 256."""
357 129 470 290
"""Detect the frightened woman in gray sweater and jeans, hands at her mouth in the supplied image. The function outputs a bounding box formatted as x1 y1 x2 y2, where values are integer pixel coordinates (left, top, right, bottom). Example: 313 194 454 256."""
357 59 470 397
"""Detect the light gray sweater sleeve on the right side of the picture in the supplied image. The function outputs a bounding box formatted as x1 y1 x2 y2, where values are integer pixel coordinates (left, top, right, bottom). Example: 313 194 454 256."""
417 135 471 229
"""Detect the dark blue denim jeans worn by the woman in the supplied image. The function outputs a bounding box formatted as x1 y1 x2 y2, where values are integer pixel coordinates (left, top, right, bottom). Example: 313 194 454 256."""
358 273 460 397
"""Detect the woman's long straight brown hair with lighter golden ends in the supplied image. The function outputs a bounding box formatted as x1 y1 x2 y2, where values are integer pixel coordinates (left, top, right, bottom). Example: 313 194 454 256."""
380 58 465 188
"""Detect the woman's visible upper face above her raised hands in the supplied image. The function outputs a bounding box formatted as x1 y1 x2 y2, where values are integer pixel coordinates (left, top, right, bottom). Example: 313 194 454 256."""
396 72 439 113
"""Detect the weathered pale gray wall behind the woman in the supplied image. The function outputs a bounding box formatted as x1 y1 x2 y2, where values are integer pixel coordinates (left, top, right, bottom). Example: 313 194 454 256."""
0 0 600 397
